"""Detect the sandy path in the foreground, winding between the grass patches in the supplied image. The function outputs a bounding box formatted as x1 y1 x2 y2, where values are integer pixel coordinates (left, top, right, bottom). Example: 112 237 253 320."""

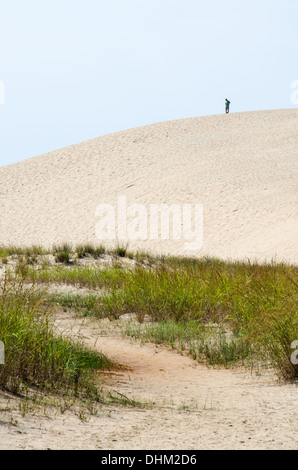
0 314 298 450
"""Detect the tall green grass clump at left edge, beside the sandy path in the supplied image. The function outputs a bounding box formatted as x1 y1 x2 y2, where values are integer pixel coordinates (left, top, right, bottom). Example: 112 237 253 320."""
0 278 111 396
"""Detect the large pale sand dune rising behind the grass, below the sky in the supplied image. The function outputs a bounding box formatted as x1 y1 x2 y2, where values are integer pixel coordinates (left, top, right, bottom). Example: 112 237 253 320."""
0 109 298 263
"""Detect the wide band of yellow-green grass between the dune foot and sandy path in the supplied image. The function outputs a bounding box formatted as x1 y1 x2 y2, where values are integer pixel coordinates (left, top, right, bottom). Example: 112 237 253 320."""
3 245 298 380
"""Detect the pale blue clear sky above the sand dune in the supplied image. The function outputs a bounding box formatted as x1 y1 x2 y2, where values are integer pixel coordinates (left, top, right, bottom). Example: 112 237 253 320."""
0 0 298 166
